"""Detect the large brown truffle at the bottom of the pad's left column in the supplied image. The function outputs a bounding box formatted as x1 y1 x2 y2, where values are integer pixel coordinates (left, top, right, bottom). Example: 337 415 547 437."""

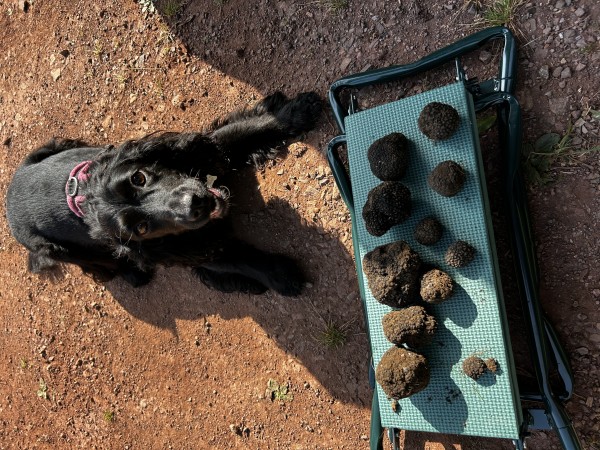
375 346 430 400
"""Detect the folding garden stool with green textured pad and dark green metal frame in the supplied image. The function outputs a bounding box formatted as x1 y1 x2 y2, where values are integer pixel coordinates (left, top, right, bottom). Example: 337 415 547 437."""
328 27 581 450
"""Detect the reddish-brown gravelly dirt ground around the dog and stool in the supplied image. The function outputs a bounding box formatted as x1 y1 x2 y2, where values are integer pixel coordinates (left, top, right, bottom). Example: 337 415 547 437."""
0 0 600 450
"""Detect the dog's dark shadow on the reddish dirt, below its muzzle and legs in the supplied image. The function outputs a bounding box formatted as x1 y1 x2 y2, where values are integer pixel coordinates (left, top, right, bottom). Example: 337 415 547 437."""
106 153 372 406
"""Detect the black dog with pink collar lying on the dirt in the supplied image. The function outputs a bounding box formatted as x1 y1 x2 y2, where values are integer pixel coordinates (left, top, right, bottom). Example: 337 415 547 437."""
6 92 321 296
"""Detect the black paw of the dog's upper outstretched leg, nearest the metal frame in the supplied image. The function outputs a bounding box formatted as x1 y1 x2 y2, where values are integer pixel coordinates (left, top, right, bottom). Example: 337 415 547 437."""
277 92 323 136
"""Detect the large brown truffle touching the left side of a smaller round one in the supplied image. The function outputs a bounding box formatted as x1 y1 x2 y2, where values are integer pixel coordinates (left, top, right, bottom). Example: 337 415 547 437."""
362 241 421 308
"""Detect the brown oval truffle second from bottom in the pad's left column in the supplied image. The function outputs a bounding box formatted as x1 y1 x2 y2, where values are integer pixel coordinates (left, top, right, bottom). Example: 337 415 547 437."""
381 306 437 348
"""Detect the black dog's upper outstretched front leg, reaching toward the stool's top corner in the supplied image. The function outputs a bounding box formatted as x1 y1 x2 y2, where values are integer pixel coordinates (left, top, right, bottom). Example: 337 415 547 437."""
209 92 322 168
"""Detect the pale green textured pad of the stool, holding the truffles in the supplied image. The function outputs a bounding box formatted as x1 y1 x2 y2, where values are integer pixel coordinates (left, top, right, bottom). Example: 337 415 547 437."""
346 82 521 439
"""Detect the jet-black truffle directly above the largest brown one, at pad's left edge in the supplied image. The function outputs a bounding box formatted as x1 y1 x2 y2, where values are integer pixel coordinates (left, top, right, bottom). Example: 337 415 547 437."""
362 181 412 236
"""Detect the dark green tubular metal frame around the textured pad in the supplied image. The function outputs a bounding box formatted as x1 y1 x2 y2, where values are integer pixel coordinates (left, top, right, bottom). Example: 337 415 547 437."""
327 27 582 450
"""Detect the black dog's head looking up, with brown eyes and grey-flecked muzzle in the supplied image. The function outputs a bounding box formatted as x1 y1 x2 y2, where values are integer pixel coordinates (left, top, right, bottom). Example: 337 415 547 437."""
86 141 229 245
